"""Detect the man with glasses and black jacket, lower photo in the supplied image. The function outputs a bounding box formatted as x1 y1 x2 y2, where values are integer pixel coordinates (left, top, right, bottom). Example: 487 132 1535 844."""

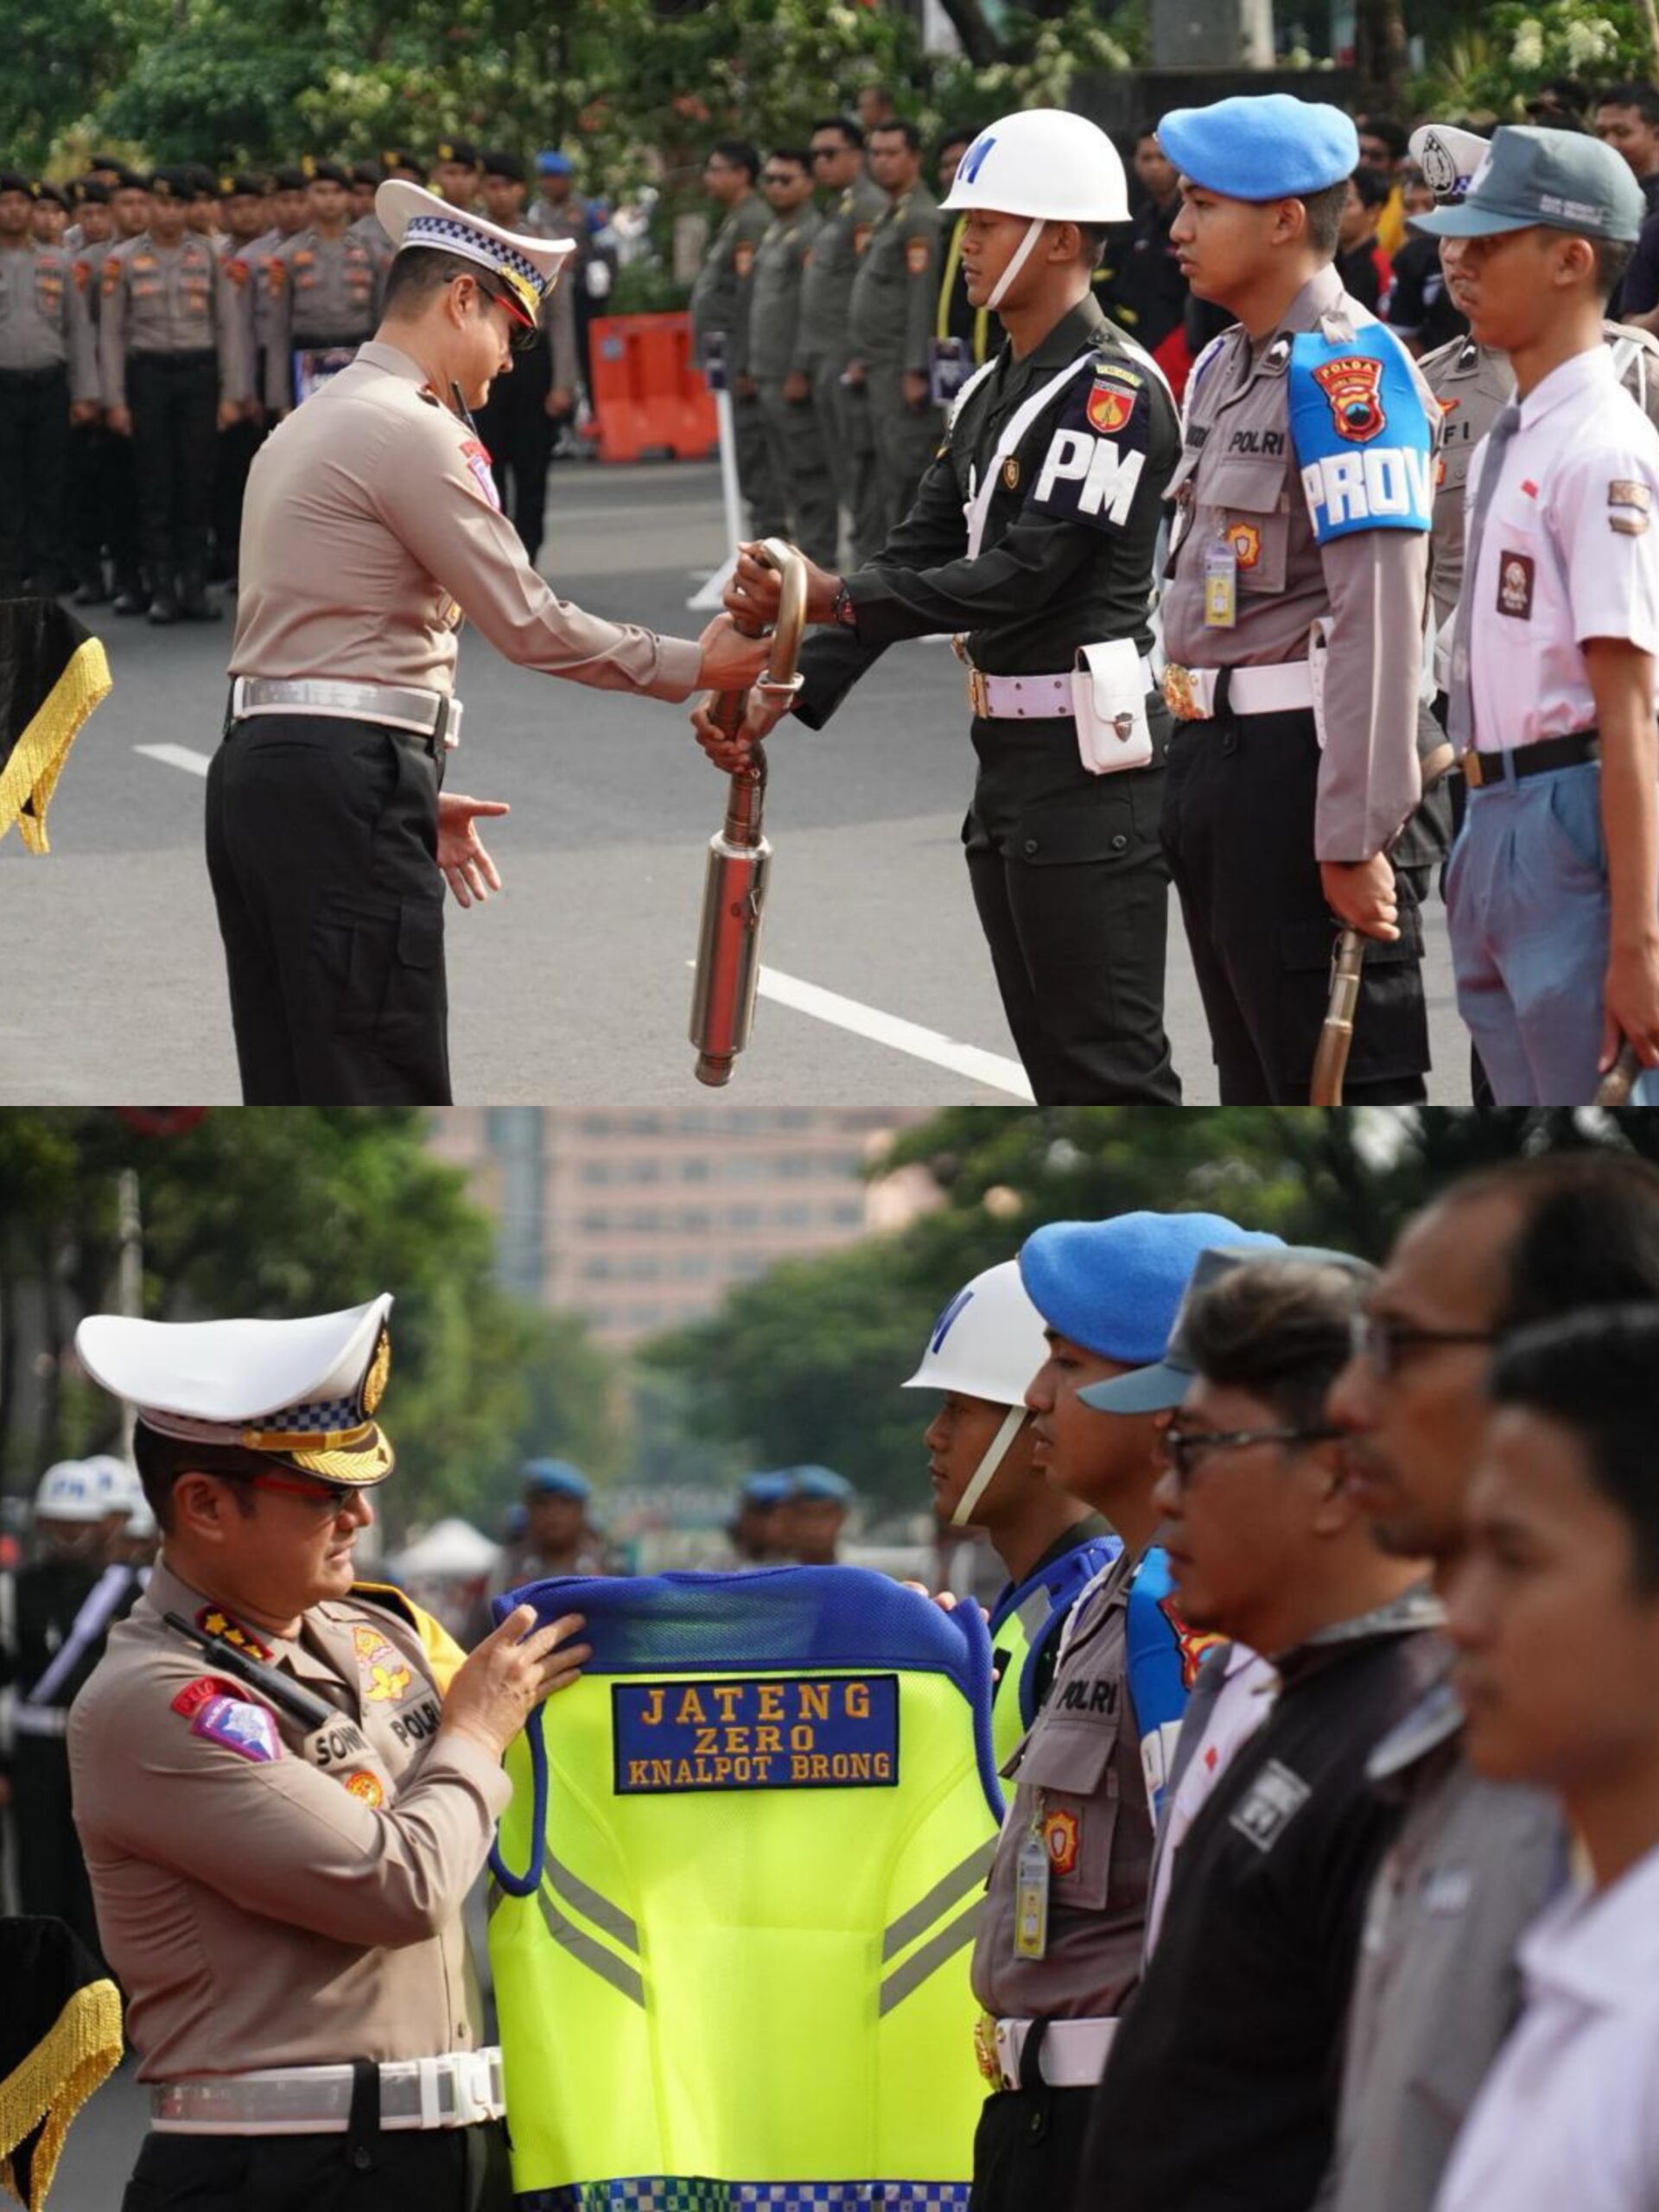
1075 1252 1442 2212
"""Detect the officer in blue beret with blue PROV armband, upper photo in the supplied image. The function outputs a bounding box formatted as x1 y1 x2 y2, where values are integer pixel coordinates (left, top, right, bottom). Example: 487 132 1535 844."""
1159 93 1438 1103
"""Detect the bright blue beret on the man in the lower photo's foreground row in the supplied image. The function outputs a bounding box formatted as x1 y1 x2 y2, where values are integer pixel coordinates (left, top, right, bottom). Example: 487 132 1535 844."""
1020 1214 1283 1367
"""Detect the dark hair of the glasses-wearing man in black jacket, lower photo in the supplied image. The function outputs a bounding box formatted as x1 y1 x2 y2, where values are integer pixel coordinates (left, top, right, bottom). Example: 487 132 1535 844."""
1181 1259 1371 1429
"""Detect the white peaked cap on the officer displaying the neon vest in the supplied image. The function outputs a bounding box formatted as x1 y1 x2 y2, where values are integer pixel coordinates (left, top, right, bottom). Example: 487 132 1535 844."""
75 1294 391 1484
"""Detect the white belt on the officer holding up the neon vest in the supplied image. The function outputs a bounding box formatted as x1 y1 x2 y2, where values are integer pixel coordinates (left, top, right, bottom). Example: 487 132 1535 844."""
150 2046 506 2134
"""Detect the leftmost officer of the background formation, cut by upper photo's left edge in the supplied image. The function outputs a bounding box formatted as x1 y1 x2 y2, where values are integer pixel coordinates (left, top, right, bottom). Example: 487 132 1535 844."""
0 173 98 597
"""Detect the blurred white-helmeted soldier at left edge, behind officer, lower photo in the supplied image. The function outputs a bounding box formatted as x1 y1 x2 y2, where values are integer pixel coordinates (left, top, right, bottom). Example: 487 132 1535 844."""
0 1460 139 1951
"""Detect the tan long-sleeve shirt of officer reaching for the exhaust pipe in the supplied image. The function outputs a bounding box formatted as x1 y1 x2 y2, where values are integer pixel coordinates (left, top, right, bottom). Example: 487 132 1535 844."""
230 340 699 699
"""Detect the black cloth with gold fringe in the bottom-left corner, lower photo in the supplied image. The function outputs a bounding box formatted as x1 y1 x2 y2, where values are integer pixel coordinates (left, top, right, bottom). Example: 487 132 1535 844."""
0 1920 122 2212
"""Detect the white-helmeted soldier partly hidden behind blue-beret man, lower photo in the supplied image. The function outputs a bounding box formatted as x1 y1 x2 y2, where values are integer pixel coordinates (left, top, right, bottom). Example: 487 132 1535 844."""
905 1259 1123 1765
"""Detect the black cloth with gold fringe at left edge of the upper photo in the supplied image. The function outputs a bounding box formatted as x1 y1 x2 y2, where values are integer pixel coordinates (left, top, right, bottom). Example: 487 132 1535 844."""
0 600 111 852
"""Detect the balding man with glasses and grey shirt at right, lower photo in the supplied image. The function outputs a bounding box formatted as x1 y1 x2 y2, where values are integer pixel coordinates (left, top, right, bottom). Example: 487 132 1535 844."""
1319 1153 1659 2212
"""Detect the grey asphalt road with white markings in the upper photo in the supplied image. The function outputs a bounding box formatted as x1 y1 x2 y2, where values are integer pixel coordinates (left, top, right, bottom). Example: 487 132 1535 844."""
0 465 1469 1106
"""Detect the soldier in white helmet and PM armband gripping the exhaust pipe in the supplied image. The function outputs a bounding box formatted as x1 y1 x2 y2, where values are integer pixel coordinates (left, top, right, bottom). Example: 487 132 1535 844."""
695 108 1181 1103
